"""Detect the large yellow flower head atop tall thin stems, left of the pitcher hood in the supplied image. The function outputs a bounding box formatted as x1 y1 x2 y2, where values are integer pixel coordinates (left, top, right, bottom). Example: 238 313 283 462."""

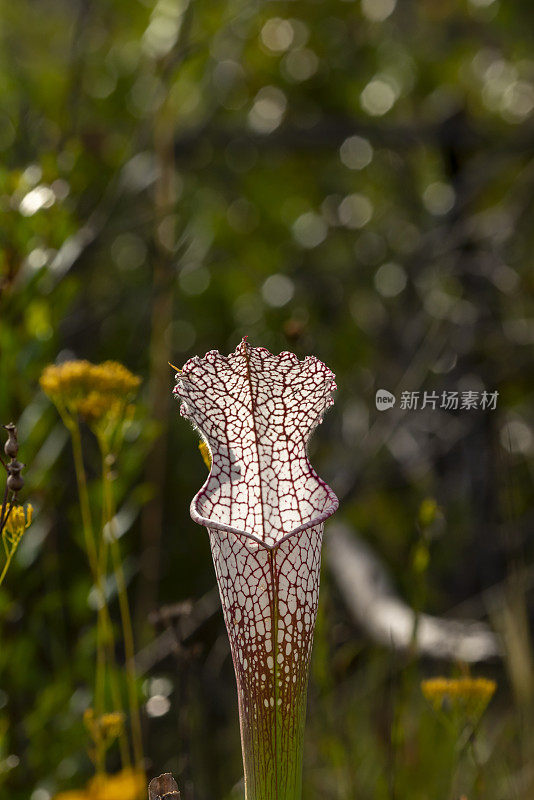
40 361 141 434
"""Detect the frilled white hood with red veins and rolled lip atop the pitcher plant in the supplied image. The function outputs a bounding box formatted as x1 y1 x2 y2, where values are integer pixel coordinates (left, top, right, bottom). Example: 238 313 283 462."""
174 339 338 549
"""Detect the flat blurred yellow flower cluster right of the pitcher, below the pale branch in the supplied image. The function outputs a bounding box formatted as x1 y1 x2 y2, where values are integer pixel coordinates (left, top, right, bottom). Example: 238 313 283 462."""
421 677 497 715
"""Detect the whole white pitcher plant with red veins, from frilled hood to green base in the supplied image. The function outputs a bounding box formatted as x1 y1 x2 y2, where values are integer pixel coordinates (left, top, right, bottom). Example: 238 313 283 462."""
174 339 338 800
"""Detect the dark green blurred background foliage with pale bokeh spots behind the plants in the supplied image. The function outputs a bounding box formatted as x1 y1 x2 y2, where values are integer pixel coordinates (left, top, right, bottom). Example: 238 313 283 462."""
0 0 534 800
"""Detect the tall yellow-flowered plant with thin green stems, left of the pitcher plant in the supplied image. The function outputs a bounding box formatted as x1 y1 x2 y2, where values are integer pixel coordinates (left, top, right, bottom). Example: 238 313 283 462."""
40 361 144 774
